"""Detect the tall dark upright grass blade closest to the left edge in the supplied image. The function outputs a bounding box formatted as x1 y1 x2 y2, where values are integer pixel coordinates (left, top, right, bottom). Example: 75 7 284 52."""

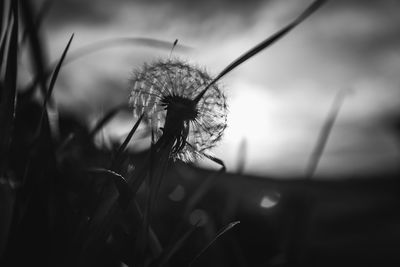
0 1 19 175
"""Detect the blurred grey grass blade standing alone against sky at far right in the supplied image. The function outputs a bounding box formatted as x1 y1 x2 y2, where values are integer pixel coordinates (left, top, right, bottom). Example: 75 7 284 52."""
306 90 348 179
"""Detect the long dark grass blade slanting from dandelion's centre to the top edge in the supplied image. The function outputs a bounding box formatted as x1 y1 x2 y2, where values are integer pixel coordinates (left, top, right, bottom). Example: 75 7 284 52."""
195 0 327 102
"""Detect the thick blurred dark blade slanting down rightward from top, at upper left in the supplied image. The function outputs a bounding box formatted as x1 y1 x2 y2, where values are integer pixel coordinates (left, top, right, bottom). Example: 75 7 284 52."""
19 0 48 96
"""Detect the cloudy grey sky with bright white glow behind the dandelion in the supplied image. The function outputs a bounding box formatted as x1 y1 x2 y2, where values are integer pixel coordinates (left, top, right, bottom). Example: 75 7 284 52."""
29 0 400 177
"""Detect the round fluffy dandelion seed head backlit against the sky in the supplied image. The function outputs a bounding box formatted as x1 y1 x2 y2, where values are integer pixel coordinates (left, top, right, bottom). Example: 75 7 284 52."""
129 59 227 162
